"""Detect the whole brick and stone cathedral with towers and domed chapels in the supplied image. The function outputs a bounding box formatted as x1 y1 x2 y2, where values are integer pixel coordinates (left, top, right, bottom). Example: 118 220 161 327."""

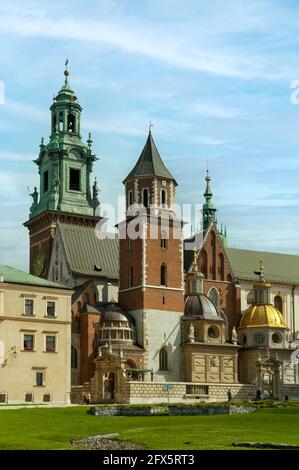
24 69 299 403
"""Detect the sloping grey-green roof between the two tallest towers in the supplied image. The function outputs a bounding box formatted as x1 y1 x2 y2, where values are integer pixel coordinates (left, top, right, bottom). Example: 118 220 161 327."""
59 224 118 279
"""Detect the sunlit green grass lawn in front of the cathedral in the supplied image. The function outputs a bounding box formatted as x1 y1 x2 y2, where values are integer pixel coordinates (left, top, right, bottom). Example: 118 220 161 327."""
0 406 299 450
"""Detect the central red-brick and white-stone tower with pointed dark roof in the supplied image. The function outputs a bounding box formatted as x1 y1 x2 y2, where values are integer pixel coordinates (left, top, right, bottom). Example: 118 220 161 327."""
119 131 184 380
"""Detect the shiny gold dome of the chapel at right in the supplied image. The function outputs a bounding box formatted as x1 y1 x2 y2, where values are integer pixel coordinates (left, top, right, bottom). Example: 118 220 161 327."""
239 305 287 328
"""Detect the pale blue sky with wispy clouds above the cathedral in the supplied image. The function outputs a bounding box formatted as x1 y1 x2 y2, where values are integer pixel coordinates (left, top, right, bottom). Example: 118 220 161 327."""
0 0 299 269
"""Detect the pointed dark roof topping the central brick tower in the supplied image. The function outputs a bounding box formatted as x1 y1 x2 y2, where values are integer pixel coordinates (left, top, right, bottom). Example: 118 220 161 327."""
123 132 177 184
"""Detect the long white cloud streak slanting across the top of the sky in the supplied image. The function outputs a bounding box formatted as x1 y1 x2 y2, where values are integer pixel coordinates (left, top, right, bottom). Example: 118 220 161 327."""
0 4 292 79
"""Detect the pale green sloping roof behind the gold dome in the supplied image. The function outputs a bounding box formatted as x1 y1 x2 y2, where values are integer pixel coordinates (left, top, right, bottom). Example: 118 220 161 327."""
225 248 299 284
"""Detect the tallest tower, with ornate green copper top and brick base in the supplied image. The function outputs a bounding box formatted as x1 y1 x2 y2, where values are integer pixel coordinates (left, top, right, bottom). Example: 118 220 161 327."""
24 61 100 278
